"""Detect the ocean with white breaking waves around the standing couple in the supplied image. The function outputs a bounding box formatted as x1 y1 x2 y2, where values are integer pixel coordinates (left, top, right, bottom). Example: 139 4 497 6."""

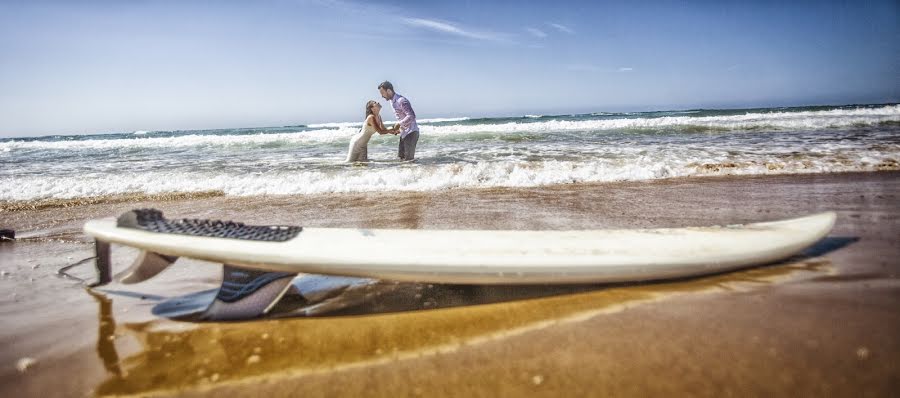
0 104 900 202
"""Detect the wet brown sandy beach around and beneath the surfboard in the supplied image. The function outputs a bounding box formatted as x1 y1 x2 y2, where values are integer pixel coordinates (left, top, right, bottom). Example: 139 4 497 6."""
0 172 900 397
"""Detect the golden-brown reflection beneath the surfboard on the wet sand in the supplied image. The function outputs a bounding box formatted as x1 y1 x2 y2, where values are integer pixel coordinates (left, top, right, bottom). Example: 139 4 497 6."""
95 258 831 395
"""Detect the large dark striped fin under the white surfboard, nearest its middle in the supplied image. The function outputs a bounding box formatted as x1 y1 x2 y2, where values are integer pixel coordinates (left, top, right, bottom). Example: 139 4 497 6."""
201 264 297 321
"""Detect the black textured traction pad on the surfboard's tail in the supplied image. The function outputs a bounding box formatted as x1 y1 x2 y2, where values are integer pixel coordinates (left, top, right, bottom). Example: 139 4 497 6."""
116 209 303 242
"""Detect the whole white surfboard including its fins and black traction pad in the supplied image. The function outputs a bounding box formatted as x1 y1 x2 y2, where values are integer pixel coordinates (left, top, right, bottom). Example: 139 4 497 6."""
84 209 835 320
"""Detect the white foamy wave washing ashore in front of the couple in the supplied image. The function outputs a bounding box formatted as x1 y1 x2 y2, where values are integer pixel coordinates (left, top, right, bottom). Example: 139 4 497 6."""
0 153 900 201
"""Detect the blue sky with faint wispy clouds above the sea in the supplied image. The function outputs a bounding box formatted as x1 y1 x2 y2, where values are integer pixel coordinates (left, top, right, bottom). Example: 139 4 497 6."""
0 0 900 137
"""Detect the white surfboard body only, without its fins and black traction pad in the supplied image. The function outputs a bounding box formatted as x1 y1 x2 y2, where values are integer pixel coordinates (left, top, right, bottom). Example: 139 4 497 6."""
84 212 835 284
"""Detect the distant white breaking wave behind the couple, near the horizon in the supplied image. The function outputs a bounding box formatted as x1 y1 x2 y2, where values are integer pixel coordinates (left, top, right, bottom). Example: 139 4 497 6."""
0 105 900 152
